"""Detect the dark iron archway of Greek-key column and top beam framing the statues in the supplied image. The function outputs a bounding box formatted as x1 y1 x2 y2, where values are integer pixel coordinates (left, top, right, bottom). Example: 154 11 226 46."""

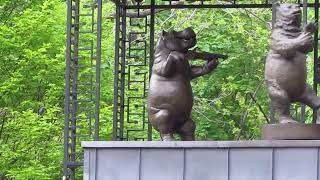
113 0 319 141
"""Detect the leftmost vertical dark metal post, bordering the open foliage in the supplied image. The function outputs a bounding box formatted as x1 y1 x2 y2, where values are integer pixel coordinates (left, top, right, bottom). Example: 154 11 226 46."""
63 0 72 179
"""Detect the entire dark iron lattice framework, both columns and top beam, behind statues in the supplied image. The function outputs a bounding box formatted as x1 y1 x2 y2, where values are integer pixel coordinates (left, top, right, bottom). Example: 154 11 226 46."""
64 0 320 179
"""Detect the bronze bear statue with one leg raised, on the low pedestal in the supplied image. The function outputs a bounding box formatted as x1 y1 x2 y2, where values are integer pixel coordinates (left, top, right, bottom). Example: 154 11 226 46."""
265 4 320 124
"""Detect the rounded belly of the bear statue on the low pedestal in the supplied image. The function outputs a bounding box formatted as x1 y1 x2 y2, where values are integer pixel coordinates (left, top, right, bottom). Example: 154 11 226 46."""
265 52 307 97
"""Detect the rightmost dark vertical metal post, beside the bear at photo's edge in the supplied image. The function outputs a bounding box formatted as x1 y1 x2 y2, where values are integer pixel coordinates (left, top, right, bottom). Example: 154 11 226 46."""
312 0 319 123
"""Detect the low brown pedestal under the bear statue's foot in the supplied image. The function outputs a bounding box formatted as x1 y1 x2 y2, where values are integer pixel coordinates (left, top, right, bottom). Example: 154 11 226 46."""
261 123 320 140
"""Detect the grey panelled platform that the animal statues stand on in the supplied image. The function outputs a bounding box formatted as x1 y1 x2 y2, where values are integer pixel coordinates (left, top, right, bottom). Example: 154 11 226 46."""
82 140 320 180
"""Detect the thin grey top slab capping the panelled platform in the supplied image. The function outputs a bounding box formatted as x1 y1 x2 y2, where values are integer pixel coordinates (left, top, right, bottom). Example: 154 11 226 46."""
81 140 320 148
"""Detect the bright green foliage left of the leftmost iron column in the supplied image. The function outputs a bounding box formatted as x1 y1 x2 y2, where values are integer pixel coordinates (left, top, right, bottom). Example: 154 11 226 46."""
0 0 66 179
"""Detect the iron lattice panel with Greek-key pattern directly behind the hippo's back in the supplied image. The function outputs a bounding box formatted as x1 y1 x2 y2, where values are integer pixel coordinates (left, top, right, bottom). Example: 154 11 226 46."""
113 2 154 141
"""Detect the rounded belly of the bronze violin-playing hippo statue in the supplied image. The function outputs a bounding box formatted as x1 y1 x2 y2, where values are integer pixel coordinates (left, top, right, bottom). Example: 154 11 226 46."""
148 74 193 115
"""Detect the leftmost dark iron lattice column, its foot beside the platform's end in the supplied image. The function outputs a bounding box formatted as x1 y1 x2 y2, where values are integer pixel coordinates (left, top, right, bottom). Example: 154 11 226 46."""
64 0 102 179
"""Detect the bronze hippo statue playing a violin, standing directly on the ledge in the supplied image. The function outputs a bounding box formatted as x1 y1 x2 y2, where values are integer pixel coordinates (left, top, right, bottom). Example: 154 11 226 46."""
148 28 227 141
